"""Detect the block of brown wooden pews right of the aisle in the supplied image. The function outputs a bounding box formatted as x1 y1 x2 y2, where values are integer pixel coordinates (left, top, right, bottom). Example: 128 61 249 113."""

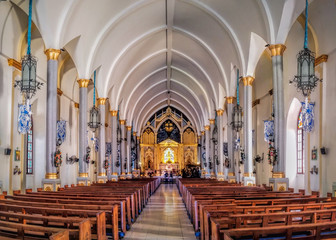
177 179 336 240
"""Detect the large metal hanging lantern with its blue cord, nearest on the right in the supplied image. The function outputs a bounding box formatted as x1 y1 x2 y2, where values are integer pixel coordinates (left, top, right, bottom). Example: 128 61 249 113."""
290 0 320 97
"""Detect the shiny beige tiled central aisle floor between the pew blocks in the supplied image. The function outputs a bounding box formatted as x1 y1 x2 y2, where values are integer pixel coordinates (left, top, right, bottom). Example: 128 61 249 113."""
125 184 196 240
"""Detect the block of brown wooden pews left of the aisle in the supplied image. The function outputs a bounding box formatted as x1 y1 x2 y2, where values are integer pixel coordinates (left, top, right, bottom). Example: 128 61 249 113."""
0 178 160 240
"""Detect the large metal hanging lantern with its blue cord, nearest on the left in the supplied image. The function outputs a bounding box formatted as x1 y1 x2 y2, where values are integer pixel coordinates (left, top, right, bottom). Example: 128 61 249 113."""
14 0 43 100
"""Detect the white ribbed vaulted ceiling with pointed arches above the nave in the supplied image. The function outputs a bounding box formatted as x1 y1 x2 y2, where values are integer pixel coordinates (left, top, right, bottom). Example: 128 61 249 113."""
12 0 312 133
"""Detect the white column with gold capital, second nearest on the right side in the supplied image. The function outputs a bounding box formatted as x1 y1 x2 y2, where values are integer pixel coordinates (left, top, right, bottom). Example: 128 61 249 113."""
243 76 255 185
